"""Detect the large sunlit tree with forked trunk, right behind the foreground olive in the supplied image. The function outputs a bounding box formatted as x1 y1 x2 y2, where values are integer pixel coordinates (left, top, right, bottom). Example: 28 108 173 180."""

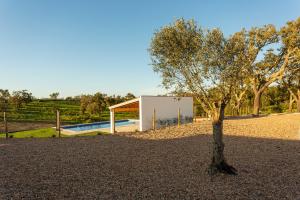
240 19 300 115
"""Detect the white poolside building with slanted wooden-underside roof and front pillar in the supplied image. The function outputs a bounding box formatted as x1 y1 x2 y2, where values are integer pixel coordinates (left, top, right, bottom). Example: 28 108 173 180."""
109 96 194 133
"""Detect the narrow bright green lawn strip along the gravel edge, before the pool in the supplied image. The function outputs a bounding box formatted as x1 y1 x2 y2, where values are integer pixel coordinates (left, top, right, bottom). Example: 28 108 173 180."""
0 128 108 138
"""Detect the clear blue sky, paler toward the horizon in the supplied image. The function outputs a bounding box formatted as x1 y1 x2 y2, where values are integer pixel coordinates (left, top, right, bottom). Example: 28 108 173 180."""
0 0 300 98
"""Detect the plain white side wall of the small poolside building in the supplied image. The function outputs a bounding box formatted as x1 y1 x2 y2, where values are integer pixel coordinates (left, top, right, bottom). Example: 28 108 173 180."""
140 96 193 131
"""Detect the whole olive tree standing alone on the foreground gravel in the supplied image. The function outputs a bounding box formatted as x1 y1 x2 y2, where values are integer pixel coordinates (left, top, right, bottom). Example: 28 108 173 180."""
149 19 244 174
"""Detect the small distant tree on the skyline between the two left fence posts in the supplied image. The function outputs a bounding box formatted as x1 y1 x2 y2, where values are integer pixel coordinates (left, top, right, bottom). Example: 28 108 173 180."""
10 90 33 110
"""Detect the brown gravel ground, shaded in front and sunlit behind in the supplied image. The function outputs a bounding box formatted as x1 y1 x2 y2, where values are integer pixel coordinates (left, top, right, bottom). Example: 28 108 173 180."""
0 114 300 200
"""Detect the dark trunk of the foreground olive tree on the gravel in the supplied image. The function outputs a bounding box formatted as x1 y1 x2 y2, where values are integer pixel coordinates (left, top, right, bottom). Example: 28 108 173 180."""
209 105 237 175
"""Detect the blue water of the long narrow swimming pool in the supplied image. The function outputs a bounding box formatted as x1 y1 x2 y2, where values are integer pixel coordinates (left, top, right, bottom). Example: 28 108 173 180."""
62 120 136 131
